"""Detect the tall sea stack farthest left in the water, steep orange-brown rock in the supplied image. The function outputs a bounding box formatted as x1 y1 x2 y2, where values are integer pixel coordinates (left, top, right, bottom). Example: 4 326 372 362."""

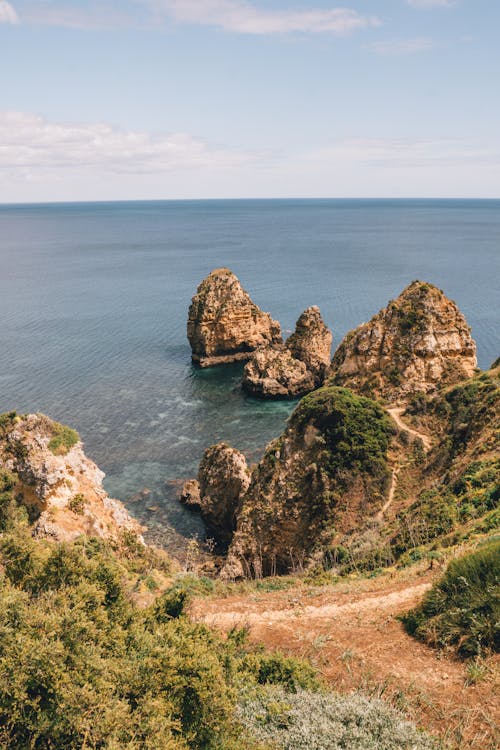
187 268 281 367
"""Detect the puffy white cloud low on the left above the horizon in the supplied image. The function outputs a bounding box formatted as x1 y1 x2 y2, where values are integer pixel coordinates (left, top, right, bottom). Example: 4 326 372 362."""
0 112 259 177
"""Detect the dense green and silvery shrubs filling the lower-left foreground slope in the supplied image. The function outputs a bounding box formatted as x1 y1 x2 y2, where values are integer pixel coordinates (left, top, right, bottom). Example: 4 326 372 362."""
0 472 431 750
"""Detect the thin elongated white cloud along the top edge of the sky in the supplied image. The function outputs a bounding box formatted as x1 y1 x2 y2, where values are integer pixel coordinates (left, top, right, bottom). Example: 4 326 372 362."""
147 0 381 34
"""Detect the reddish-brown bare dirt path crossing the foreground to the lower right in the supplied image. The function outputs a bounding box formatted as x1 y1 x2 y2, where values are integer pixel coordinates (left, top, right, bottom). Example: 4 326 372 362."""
192 571 500 750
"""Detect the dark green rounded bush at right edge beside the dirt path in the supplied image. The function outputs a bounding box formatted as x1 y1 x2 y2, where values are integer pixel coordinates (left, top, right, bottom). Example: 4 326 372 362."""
402 540 500 657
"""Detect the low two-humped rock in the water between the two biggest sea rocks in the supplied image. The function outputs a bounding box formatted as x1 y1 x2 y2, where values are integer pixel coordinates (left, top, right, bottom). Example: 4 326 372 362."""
243 307 332 398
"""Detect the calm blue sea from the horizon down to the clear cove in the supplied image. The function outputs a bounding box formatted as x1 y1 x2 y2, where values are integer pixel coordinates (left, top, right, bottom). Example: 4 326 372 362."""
0 200 500 545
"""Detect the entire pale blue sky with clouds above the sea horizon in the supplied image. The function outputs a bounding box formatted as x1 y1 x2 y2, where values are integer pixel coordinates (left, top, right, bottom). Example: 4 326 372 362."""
0 0 500 203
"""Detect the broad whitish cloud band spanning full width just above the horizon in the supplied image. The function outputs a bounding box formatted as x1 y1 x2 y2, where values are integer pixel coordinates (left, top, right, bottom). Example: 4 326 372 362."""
0 112 500 202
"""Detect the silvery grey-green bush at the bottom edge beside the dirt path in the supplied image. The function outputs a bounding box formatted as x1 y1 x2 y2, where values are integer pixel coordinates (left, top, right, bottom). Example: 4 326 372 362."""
238 688 435 750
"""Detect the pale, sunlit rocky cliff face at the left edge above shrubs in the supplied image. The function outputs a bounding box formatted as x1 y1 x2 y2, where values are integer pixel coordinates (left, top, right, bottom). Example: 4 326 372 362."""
0 414 142 541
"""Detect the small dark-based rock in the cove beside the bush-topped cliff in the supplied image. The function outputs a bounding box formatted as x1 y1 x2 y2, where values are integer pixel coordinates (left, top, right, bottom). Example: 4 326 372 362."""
181 443 250 547
